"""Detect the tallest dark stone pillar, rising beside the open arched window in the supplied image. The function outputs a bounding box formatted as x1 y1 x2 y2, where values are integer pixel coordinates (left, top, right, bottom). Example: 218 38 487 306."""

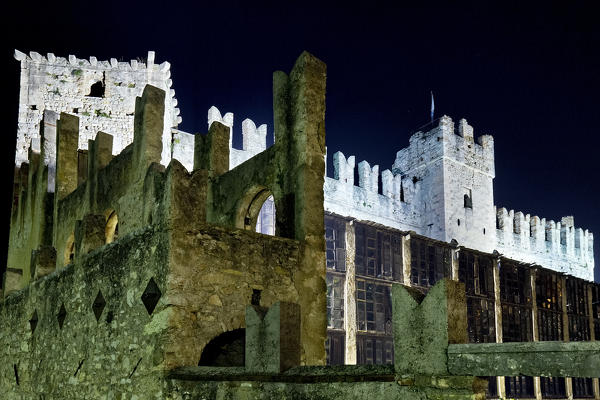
273 52 327 365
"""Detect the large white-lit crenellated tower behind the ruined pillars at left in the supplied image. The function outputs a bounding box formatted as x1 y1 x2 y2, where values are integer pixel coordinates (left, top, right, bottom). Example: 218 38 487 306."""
14 50 181 166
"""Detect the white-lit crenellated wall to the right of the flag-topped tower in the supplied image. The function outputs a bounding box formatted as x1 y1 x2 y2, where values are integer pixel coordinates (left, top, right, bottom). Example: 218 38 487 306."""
496 207 594 281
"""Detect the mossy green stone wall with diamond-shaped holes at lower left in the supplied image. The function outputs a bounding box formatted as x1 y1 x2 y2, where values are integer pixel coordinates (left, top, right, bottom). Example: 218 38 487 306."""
0 227 168 399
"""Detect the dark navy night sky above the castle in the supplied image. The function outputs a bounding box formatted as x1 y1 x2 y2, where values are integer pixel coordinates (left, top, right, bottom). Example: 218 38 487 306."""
0 1 600 281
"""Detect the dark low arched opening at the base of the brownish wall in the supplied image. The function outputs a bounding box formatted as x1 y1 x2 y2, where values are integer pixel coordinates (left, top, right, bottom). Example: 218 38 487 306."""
198 328 246 367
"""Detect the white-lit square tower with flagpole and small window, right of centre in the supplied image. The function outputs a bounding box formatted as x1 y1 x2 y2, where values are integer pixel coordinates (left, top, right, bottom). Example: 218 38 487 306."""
393 116 496 252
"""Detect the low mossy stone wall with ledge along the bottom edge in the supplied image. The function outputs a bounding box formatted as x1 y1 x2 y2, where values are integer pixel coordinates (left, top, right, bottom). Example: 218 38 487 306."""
167 365 485 400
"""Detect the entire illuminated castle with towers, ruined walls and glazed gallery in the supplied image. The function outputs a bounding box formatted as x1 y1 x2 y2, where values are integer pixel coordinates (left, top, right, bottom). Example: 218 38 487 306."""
0 51 600 398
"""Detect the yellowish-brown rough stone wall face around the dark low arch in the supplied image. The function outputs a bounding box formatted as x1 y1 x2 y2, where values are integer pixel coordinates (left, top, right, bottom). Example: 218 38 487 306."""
166 225 304 367
